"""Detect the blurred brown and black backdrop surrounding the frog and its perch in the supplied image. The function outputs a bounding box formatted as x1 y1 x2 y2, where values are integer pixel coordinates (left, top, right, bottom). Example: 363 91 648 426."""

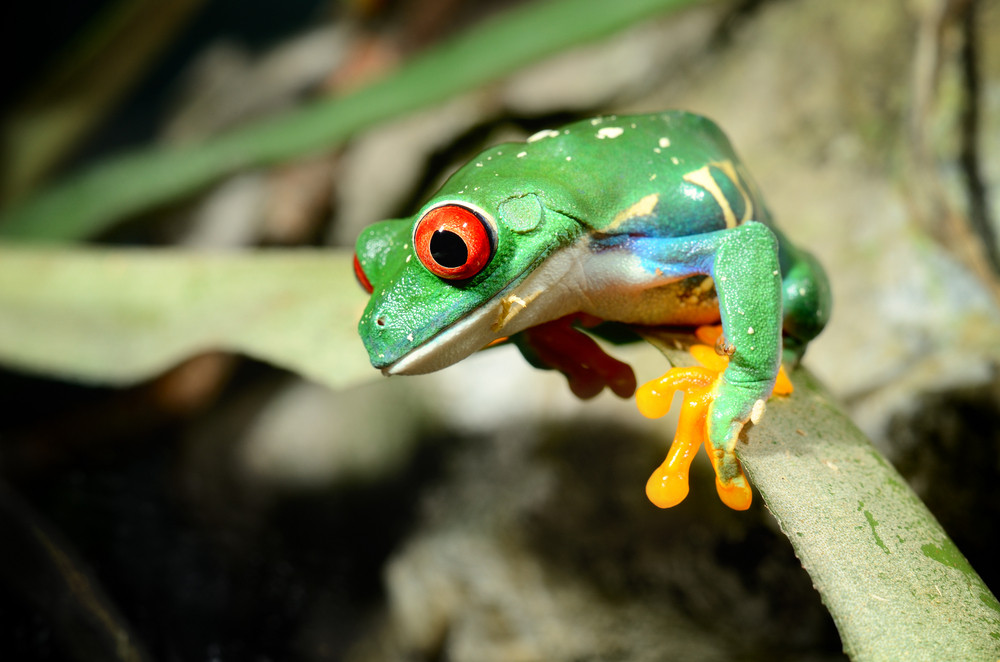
0 0 1000 661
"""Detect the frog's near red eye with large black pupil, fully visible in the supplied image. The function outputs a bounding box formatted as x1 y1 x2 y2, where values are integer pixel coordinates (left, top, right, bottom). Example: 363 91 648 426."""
413 205 493 280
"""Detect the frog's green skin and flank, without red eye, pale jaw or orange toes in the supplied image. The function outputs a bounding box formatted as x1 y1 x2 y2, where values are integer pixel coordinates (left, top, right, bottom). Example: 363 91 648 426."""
357 111 830 482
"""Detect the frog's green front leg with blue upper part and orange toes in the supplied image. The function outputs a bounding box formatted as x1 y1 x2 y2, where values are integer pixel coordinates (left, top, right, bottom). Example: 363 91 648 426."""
637 222 782 510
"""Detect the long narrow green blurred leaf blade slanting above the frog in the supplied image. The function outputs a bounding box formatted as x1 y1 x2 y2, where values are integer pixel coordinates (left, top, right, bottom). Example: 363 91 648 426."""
0 0 698 241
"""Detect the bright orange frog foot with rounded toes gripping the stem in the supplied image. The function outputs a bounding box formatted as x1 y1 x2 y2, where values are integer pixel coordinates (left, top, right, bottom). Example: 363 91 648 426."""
636 326 792 510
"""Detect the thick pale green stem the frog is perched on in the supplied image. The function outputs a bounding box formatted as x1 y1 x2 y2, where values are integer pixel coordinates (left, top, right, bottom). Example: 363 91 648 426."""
644 334 1000 660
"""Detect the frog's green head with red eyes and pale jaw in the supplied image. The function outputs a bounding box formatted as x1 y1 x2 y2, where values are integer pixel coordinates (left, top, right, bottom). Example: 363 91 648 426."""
355 181 582 374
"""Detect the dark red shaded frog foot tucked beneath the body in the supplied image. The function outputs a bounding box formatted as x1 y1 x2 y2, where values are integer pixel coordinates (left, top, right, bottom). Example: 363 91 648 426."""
518 313 636 400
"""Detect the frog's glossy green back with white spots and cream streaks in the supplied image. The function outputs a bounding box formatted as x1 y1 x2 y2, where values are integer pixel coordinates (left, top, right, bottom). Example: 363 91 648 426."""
439 111 770 244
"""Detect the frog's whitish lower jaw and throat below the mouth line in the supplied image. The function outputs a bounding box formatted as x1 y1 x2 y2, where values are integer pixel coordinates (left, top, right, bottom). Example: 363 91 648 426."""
382 246 582 376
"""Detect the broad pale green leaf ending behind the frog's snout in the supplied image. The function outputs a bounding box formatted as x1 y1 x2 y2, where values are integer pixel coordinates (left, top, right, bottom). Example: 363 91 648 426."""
0 245 379 388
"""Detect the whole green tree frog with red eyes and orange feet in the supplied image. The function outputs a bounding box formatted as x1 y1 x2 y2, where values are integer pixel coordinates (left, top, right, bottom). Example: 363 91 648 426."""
354 110 831 510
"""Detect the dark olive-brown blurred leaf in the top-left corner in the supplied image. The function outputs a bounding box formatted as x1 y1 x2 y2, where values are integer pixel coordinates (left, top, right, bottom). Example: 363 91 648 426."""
0 0 203 200
